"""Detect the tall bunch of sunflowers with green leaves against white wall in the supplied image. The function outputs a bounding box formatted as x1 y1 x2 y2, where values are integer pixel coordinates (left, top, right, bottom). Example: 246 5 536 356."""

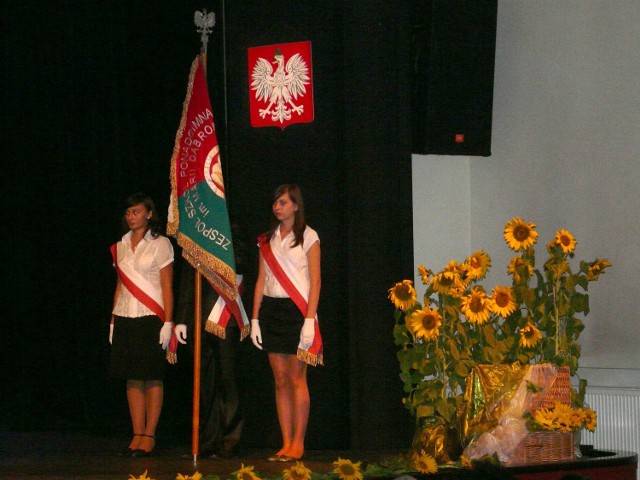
389 217 611 436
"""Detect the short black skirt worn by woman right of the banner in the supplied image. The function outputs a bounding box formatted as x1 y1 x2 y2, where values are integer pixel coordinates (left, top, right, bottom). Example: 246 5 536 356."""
260 296 304 355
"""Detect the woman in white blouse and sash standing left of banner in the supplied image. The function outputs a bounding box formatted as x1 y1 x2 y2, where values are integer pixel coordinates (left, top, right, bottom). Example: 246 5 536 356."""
109 193 173 457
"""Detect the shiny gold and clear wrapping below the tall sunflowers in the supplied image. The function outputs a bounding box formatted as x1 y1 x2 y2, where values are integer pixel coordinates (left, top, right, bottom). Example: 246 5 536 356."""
462 364 570 465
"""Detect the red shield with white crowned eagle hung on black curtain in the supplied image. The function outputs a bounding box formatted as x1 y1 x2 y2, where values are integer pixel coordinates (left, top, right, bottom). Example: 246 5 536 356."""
248 41 314 128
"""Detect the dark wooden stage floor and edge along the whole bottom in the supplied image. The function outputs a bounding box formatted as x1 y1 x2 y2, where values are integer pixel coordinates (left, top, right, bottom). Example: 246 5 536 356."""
0 430 638 480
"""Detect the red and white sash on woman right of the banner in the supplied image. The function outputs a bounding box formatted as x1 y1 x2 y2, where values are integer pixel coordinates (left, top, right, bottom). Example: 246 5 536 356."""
258 236 323 366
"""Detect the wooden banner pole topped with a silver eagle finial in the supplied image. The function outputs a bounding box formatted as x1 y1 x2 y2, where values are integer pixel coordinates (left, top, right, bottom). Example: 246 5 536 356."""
191 9 216 465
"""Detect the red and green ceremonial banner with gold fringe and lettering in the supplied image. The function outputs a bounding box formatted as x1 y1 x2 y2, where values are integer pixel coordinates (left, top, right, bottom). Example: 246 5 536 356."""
167 57 238 300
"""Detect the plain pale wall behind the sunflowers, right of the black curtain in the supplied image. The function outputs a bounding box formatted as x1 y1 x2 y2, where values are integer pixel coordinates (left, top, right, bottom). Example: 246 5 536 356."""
413 0 640 388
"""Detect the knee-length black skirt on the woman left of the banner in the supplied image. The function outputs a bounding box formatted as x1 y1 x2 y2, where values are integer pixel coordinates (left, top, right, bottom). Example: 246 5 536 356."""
109 315 167 380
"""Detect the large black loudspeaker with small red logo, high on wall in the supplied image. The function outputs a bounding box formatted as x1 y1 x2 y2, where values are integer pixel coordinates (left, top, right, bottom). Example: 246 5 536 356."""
411 0 498 156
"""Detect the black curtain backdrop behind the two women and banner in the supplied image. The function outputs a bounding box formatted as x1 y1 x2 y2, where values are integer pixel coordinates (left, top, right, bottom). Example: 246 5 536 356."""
0 0 413 449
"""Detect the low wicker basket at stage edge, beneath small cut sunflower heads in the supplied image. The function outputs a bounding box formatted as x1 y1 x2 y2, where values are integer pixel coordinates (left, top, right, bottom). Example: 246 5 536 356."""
509 432 574 465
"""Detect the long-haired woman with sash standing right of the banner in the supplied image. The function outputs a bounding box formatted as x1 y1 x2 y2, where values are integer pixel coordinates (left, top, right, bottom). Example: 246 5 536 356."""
251 184 322 462
